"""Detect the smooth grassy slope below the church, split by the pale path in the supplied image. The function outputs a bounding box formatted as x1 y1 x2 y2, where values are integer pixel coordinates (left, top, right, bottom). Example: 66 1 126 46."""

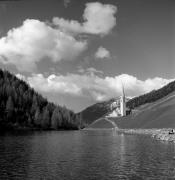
90 92 175 128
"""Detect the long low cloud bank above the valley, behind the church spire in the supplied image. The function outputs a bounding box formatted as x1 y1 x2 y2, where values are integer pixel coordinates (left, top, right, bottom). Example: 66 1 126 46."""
17 73 173 101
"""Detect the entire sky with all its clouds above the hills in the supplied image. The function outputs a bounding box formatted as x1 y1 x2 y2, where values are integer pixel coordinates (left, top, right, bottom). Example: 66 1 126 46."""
0 0 175 112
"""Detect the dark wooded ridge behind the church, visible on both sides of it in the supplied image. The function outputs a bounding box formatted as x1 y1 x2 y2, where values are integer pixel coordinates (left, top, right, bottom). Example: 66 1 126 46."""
79 81 175 125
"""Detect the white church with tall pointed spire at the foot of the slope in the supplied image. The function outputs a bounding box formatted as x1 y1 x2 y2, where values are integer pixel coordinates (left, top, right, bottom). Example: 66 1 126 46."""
106 85 128 117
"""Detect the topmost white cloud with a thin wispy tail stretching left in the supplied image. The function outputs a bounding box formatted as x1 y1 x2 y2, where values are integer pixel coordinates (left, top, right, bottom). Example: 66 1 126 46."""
53 2 117 36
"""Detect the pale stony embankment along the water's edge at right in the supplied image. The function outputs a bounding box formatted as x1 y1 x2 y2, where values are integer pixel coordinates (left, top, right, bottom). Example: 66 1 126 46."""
120 129 175 143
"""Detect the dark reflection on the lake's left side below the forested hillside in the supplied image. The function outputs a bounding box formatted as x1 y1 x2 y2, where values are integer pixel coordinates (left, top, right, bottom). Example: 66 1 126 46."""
0 135 32 179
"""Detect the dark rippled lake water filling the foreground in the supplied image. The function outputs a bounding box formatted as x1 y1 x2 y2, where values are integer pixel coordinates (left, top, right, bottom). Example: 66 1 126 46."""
0 130 175 180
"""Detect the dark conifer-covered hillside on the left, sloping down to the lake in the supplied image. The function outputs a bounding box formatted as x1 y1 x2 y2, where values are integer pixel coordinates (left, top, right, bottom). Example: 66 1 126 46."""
0 70 80 130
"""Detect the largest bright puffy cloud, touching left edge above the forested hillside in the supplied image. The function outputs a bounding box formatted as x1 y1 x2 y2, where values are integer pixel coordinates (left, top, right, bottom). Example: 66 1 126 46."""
0 19 87 71
